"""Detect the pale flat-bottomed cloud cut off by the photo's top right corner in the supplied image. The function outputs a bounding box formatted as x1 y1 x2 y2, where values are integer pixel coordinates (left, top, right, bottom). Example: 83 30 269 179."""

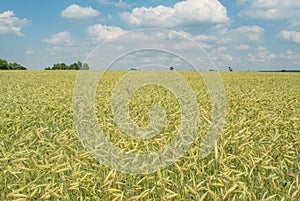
240 0 300 20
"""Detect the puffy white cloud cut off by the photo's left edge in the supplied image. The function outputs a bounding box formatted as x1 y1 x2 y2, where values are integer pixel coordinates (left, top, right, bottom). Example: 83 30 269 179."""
0 10 31 36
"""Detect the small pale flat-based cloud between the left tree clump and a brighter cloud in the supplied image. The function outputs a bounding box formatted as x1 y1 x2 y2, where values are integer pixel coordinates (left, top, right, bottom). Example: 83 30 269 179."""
42 31 74 45
